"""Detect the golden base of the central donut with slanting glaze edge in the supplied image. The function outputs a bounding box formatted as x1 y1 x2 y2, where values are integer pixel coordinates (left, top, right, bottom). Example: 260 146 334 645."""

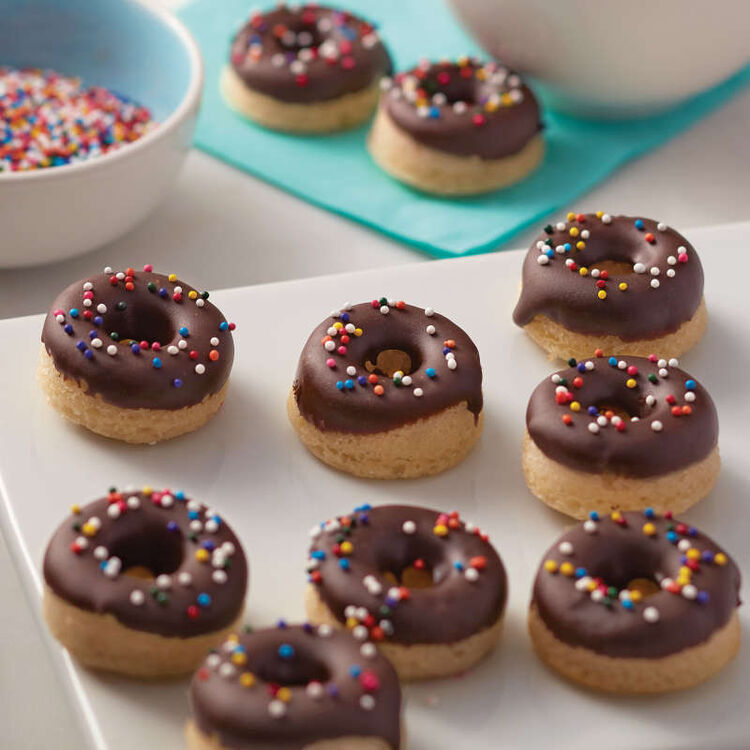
287 391 483 479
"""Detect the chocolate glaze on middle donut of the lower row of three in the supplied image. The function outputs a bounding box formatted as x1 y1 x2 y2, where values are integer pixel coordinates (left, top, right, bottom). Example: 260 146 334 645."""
308 505 508 644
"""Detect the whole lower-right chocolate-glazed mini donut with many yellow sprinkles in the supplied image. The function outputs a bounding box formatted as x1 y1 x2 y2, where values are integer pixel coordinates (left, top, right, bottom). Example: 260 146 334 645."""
529 509 740 693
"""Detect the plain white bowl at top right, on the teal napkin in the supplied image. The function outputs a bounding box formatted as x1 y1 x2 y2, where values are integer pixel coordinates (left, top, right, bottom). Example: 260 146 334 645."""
450 0 750 117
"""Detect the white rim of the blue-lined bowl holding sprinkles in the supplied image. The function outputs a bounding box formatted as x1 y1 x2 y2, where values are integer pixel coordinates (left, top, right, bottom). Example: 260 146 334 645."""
0 0 205 185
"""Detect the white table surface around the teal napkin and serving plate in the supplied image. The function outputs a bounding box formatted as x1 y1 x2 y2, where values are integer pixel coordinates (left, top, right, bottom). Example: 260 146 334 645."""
0 0 750 750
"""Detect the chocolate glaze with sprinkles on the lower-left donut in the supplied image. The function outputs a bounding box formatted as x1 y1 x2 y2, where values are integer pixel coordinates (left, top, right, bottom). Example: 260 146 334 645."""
44 490 248 638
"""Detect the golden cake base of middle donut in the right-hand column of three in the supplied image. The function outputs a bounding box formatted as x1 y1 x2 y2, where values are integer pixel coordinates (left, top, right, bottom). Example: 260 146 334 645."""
521 431 721 520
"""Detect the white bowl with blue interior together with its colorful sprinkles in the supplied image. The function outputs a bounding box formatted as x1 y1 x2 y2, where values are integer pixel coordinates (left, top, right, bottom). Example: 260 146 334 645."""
0 0 203 268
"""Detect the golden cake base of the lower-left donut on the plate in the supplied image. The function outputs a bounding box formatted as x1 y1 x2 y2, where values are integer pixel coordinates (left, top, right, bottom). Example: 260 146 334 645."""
42 586 242 679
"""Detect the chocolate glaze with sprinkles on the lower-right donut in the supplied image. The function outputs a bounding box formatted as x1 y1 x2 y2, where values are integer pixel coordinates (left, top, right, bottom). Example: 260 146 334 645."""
532 512 740 659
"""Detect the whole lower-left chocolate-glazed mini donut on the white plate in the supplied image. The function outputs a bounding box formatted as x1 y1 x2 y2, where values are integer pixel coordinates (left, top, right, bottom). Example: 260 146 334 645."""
44 487 247 677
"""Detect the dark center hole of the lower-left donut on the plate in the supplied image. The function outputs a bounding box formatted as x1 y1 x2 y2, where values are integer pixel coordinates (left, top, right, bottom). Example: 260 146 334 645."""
109 522 183 580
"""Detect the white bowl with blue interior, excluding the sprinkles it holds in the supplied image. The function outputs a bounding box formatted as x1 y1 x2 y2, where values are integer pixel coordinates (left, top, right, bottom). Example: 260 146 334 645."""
0 0 203 268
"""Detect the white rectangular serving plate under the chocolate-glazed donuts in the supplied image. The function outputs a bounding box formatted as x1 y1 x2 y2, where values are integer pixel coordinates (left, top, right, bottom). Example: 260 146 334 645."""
0 223 750 750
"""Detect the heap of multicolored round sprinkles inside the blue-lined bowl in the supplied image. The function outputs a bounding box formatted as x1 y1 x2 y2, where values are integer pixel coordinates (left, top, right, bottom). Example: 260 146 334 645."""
0 66 156 174
